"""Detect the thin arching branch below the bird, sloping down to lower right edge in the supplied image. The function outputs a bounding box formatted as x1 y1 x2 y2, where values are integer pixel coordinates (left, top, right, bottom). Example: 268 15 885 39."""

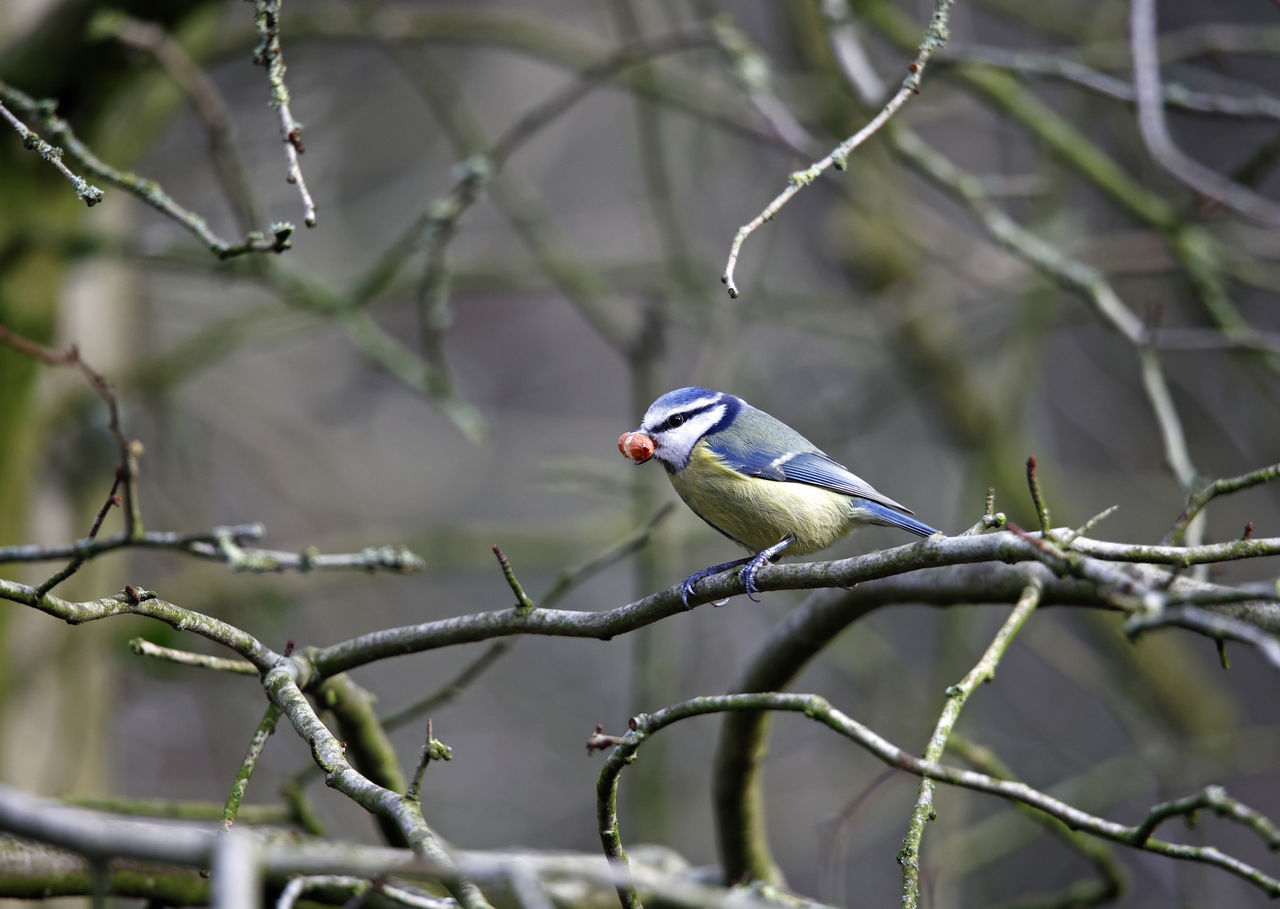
598 691 1280 903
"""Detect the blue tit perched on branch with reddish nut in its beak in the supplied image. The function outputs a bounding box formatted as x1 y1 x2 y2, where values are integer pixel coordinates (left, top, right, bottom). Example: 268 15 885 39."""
618 388 938 607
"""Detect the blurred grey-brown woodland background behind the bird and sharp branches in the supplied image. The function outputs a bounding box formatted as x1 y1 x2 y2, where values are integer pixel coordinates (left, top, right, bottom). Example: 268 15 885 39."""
0 0 1280 906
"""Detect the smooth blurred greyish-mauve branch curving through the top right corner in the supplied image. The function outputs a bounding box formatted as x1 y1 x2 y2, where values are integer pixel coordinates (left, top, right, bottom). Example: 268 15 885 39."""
1129 0 1280 227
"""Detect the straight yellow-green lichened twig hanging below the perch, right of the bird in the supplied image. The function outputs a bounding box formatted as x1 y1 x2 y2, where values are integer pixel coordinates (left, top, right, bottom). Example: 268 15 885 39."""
897 581 1041 909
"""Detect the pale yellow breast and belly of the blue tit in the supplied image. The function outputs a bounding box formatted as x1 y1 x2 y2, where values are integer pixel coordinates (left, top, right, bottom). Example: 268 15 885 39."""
668 442 854 556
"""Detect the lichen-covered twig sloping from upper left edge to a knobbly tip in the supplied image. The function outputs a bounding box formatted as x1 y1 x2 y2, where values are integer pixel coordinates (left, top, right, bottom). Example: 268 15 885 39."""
0 82 293 259
